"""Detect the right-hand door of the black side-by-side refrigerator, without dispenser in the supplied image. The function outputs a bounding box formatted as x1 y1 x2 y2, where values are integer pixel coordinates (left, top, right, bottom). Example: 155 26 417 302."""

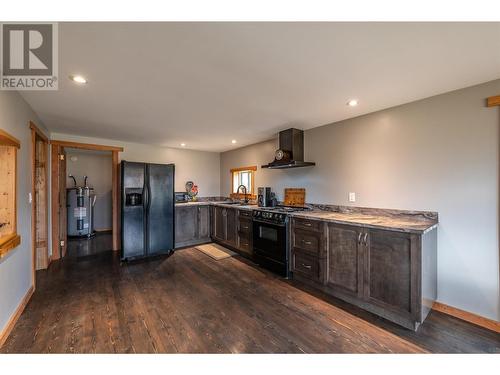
146 164 175 255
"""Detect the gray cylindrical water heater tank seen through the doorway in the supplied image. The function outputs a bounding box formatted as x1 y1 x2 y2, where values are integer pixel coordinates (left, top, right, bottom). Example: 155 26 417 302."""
66 186 96 237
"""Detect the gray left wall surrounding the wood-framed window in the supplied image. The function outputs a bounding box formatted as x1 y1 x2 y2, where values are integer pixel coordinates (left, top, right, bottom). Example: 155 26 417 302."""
0 91 48 332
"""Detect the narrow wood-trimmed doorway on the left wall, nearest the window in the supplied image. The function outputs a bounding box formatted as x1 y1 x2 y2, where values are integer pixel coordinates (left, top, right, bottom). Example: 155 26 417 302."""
30 122 50 270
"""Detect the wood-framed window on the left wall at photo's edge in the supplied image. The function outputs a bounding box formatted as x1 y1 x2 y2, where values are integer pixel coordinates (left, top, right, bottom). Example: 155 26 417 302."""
0 130 21 258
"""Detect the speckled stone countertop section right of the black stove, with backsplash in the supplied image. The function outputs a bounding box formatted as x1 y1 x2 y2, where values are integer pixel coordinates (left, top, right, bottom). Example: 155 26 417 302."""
290 206 438 234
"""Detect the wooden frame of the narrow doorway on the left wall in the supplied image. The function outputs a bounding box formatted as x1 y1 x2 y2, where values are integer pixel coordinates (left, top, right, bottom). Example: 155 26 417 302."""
28 121 50 288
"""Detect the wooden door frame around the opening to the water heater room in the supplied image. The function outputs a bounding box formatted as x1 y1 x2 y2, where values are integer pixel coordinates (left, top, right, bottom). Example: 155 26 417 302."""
50 140 123 259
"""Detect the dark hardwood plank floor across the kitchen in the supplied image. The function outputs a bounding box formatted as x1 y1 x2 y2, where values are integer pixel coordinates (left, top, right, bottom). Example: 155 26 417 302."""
0 235 500 353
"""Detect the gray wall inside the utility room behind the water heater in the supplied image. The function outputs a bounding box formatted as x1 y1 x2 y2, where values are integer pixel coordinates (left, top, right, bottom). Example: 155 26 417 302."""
66 149 113 230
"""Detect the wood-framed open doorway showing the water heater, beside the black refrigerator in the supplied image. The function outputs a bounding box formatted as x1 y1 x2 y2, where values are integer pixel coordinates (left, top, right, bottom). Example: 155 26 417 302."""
51 141 123 259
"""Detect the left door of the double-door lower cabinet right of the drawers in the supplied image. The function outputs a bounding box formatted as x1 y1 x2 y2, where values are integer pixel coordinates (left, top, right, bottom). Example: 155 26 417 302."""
325 224 364 297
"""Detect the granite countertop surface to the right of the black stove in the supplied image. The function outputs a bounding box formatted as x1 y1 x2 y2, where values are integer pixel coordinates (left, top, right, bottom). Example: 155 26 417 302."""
290 210 438 234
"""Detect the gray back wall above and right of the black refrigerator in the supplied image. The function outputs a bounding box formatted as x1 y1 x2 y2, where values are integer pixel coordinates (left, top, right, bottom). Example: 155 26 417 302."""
52 133 220 197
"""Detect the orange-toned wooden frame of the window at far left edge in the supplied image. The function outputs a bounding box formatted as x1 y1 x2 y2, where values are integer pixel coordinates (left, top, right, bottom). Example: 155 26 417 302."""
0 129 21 259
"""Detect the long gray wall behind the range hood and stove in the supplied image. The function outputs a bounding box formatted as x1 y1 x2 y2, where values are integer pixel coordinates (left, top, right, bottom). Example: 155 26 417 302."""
221 80 500 320
